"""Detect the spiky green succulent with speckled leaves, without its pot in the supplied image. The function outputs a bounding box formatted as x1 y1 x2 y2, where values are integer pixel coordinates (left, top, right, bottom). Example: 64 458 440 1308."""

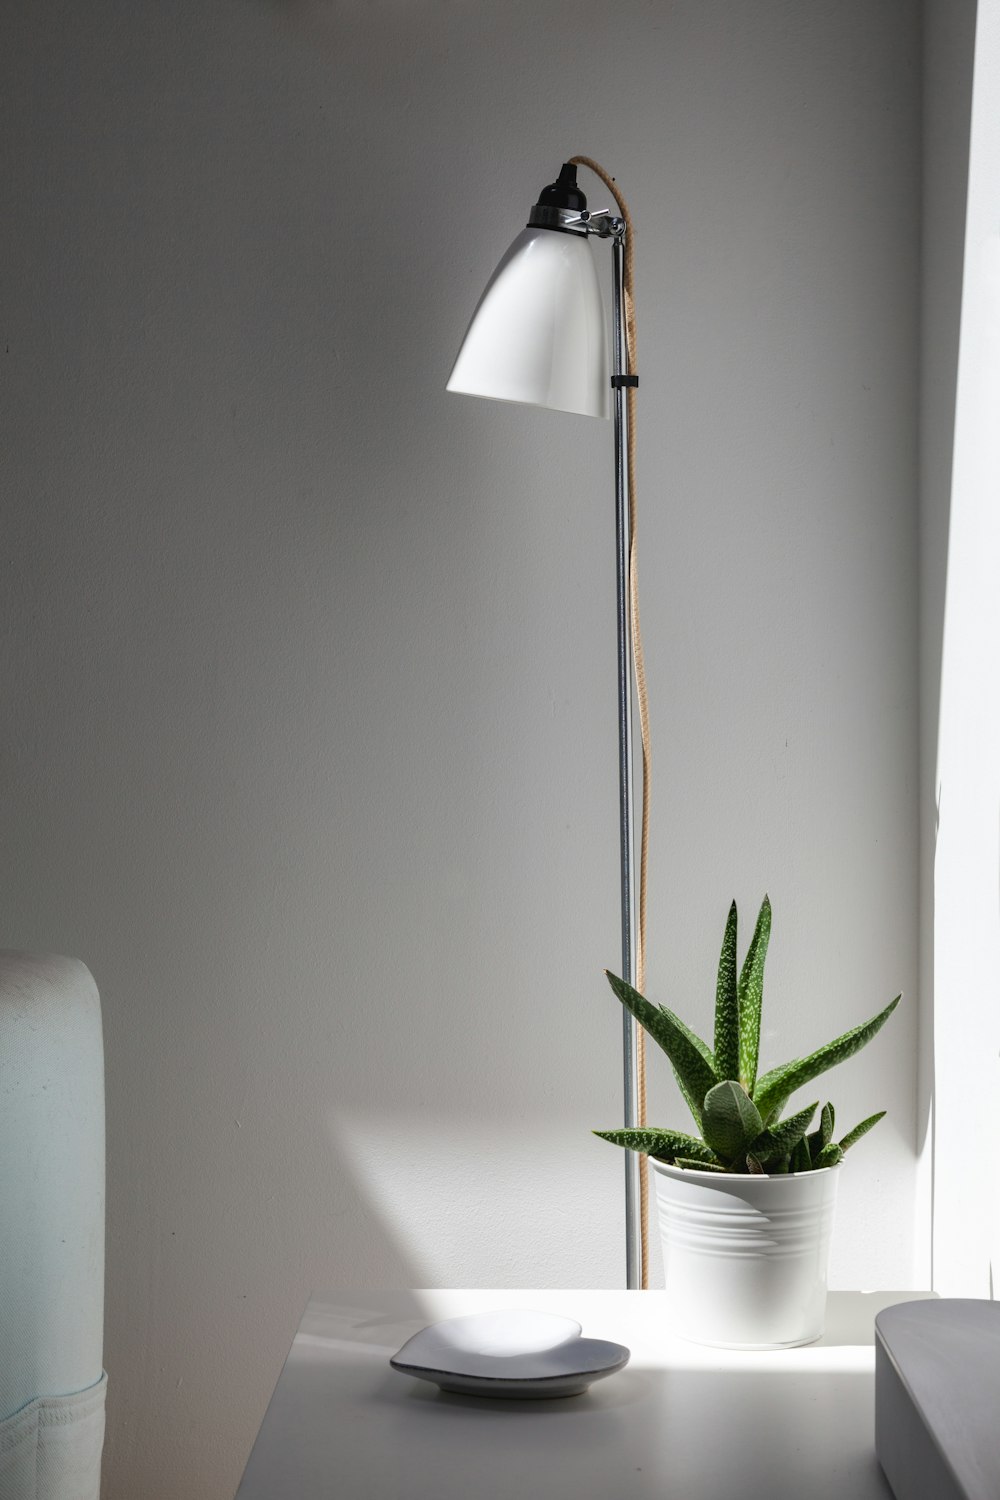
594 896 901 1175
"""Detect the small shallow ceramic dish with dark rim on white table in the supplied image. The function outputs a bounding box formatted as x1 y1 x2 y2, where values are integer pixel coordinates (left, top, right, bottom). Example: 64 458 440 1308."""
390 1308 628 1401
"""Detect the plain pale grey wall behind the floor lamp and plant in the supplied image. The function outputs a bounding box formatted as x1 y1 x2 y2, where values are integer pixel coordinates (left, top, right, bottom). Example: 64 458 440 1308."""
0 0 919 1500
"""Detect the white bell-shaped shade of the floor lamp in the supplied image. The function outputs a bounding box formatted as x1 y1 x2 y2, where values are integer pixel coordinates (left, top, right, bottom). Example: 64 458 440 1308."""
448 228 612 417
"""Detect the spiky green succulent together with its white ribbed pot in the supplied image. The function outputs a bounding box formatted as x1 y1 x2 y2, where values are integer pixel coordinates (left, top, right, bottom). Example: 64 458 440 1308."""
594 896 900 1349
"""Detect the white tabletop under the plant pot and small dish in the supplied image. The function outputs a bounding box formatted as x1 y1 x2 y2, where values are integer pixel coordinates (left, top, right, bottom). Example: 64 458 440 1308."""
237 1292 927 1500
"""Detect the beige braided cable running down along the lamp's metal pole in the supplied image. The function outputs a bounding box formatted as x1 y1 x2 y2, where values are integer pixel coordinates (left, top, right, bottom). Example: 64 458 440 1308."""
570 156 652 1292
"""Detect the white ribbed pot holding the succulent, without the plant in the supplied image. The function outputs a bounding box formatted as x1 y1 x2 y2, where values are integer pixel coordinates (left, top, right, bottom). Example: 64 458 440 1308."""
649 1157 840 1349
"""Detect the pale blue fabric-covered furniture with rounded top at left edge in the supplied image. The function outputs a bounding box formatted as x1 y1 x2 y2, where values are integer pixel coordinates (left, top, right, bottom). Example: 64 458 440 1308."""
0 951 105 1500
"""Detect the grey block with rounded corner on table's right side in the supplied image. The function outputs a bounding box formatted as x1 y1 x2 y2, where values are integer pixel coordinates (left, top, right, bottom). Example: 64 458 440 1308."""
876 1298 1000 1500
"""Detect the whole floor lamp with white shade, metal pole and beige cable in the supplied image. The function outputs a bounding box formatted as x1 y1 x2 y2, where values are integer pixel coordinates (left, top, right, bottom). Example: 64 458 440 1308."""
448 158 649 1289
